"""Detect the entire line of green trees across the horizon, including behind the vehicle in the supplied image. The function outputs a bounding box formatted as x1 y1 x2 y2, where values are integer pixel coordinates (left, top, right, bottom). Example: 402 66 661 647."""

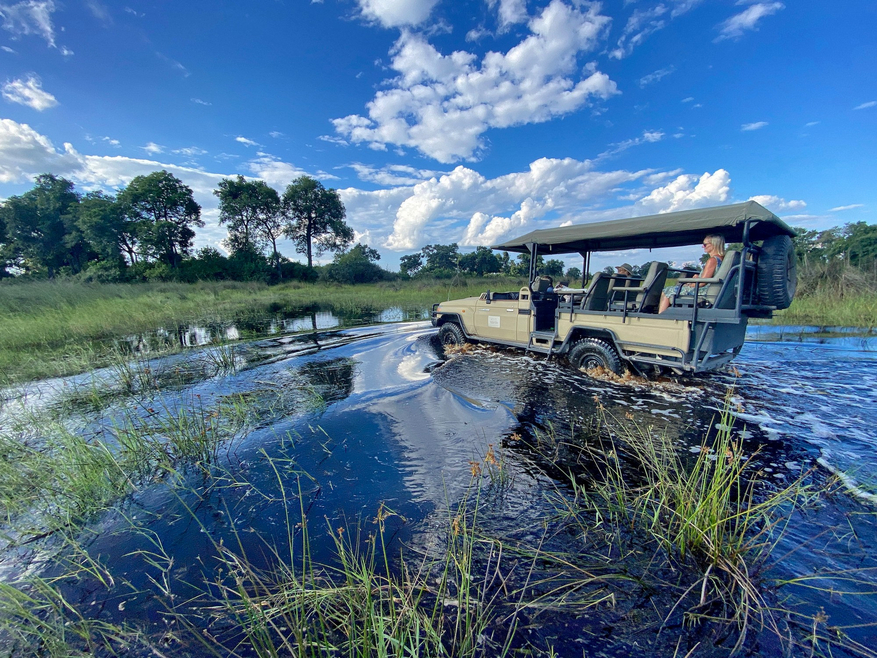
0 171 877 283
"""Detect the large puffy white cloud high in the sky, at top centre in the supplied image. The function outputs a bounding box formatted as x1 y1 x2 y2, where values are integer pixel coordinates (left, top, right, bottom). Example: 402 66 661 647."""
333 0 618 163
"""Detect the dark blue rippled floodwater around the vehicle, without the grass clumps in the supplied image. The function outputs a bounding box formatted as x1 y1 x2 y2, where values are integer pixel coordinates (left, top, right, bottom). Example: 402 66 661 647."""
0 319 877 656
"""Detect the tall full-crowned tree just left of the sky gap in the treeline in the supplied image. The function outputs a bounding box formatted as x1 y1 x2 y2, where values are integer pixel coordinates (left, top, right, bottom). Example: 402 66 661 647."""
118 170 204 267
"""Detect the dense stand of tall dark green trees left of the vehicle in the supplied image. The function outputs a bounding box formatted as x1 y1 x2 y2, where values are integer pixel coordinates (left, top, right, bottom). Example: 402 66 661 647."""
0 171 360 282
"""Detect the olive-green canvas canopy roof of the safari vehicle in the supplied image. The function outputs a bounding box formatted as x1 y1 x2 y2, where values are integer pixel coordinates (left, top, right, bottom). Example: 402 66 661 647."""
492 201 795 256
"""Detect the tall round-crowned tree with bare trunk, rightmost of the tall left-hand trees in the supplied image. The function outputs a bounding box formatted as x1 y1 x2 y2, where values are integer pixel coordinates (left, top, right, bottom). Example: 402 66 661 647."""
281 176 353 267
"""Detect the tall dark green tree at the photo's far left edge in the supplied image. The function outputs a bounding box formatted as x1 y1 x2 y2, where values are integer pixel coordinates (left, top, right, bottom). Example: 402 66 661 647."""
2 174 89 278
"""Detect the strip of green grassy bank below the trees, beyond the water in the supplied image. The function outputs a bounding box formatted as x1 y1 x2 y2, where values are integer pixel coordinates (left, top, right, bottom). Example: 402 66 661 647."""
0 278 521 385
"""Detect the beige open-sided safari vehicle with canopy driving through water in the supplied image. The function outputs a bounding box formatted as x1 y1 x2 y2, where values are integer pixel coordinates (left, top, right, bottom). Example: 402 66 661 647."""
432 201 797 374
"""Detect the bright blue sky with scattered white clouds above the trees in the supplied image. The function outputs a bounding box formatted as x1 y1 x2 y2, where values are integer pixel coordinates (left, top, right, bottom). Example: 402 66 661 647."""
0 0 877 269
